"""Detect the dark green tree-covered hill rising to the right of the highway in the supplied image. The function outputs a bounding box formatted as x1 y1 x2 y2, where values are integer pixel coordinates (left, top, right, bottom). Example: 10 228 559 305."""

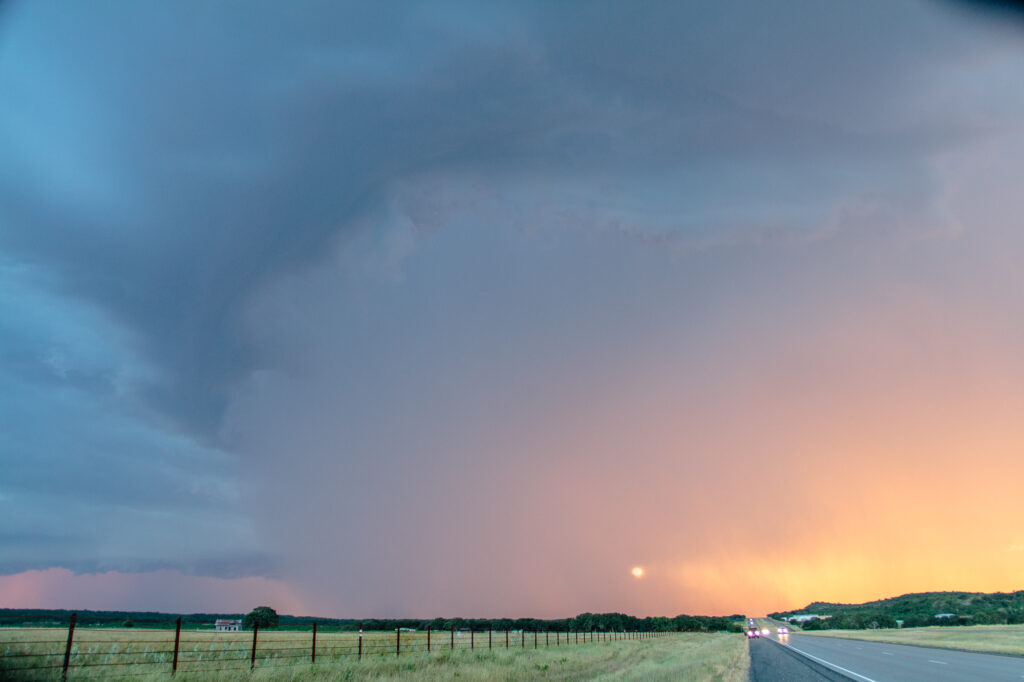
769 590 1024 630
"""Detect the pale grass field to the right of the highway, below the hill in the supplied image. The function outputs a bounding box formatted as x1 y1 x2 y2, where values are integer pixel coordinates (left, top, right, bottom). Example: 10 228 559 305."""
804 625 1024 654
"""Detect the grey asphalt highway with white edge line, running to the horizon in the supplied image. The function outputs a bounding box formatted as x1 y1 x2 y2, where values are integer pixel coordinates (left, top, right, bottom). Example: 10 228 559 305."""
751 629 1024 682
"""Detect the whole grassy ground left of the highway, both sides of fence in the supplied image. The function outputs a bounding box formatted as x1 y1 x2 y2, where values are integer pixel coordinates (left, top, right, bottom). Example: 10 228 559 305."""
0 628 750 682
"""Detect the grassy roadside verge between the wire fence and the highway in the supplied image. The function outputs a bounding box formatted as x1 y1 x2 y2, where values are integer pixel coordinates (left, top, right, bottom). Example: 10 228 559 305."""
0 631 750 682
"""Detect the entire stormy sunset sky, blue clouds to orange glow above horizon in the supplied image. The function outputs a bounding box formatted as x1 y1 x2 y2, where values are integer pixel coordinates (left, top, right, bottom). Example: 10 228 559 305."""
0 0 1024 617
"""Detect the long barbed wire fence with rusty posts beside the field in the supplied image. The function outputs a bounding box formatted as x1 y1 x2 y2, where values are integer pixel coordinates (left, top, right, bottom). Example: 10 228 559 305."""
0 613 673 680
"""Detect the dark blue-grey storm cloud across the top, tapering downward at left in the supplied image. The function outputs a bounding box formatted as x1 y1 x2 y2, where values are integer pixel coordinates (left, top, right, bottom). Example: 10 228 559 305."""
0 3 1007 436
